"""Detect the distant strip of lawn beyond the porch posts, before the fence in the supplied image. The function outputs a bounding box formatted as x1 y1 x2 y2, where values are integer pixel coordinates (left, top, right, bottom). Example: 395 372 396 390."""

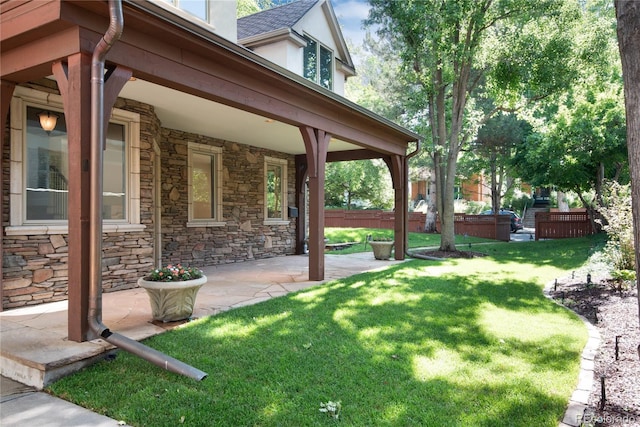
324 227 495 254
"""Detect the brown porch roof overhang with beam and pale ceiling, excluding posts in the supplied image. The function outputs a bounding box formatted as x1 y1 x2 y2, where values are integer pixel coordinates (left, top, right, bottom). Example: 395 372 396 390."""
0 0 419 155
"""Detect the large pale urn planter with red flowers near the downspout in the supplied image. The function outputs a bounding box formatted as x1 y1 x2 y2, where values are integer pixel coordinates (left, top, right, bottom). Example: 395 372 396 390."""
138 264 207 322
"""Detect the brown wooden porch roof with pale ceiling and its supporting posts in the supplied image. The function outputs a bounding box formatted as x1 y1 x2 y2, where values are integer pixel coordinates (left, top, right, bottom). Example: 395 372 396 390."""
0 0 418 342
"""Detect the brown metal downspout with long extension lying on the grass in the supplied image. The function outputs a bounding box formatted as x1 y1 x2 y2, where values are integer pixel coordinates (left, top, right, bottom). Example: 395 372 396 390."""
87 0 207 381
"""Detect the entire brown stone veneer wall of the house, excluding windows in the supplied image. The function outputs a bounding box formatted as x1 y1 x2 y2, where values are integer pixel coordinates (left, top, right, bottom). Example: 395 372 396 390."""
1 88 295 309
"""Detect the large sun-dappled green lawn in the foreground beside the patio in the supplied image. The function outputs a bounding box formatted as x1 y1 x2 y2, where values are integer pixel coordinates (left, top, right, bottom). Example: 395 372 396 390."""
49 238 594 427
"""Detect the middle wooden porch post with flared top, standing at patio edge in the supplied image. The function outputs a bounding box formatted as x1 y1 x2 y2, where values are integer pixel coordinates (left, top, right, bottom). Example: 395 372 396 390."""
300 126 331 280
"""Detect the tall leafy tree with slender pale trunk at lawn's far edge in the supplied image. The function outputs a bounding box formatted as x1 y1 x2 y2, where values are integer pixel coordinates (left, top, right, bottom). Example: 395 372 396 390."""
368 0 577 251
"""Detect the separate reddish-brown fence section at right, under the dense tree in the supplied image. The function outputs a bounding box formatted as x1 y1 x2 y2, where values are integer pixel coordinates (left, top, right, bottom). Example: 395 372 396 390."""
536 212 595 240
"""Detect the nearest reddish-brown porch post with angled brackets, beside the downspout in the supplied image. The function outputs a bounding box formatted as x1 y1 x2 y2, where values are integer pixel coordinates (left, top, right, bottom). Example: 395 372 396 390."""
53 53 131 342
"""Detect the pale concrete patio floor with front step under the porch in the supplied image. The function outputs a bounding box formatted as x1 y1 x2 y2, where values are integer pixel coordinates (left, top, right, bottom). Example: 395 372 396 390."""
0 252 401 389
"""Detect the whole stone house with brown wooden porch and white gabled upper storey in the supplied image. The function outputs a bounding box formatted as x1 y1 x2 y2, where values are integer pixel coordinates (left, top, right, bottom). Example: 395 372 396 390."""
0 0 418 341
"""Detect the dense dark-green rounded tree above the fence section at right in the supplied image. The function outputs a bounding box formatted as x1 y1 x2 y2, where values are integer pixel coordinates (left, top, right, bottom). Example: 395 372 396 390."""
514 85 628 209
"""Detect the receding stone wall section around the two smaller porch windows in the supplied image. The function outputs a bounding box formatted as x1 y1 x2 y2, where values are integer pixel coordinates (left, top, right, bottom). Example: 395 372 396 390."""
161 129 295 267
